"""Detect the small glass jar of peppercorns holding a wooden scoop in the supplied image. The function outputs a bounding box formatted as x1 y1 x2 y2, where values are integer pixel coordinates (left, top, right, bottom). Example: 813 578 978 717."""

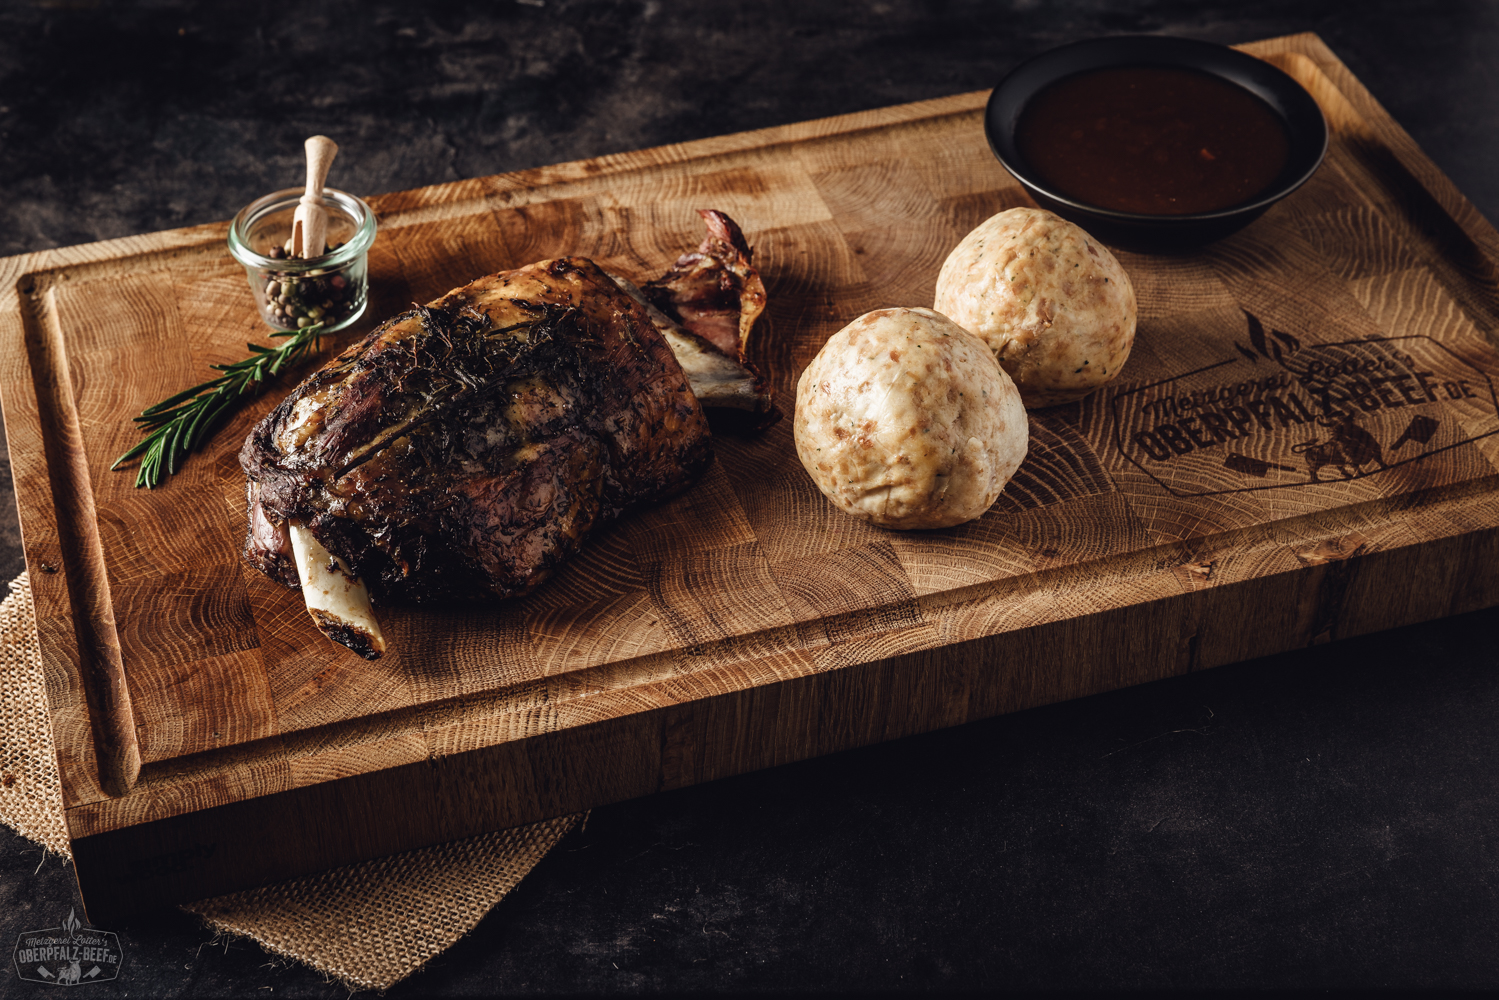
229 187 375 333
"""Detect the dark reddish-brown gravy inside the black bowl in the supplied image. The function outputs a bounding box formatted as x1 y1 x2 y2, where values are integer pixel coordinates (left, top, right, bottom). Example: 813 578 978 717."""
1015 66 1291 216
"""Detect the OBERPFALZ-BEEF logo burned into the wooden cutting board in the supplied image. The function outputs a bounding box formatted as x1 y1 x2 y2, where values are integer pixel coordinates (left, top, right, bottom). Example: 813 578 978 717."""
1111 312 1499 496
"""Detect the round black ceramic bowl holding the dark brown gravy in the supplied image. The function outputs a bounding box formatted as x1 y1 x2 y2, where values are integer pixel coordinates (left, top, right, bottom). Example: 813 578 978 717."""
983 36 1327 250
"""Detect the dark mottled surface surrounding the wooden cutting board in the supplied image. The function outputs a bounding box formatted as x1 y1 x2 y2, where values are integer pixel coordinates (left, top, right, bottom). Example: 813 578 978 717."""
0 0 1499 997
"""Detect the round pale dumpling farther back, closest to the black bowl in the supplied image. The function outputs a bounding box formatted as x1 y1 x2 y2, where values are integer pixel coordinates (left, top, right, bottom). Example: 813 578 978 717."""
934 208 1135 409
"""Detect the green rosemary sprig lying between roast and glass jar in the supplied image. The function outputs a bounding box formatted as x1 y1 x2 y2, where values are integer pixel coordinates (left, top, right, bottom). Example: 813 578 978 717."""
109 322 324 489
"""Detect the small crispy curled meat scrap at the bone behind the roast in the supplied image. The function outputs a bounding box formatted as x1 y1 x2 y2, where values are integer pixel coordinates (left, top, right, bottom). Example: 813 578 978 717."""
642 208 764 363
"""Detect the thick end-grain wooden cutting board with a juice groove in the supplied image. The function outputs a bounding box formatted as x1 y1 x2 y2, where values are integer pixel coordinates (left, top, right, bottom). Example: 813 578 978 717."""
0 34 1499 924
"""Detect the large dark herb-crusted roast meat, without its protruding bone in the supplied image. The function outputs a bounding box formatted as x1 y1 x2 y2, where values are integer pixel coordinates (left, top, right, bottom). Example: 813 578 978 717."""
240 258 711 603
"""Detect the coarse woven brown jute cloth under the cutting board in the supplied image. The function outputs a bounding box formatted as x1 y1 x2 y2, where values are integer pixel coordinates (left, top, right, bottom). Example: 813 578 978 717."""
0 573 582 990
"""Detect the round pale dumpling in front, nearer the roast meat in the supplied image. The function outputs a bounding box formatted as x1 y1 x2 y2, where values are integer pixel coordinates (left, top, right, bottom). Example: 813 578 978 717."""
794 309 1030 528
